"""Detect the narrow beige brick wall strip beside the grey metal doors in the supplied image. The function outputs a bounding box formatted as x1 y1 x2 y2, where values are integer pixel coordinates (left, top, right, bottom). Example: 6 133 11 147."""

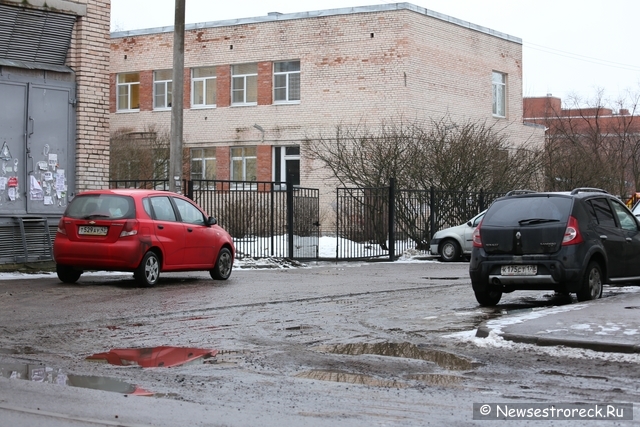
67 0 111 191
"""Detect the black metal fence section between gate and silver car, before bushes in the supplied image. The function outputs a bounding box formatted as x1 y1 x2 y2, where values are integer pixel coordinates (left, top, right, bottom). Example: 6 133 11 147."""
336 180 504 259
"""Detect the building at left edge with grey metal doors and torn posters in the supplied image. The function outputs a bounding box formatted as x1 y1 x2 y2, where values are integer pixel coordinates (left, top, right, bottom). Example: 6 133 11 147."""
0 0 111 262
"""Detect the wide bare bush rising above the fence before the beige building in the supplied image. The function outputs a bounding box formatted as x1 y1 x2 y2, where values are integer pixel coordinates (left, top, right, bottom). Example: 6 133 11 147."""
305 117 542 191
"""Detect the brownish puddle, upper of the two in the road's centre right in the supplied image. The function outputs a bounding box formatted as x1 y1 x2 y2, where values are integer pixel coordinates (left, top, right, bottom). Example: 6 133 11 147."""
318 342 473 371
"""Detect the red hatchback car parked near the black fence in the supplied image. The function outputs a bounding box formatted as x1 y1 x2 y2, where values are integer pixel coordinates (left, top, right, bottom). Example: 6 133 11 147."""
53 189 235 286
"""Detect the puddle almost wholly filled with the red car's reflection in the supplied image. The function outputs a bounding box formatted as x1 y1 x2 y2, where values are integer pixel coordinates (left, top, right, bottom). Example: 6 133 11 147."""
87 346 218 368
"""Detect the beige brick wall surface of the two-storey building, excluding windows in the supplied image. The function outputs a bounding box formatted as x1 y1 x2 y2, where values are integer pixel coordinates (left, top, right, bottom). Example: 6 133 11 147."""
111 7 543 228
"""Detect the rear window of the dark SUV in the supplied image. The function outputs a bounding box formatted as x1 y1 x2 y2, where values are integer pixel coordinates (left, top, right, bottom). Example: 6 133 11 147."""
482 195 572 227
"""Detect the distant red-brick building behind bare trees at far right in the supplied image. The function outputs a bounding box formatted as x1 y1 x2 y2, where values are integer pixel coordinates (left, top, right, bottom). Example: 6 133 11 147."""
523 95 640 197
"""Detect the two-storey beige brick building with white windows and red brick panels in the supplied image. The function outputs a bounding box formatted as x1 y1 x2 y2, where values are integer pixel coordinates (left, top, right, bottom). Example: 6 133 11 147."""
110 3 543 221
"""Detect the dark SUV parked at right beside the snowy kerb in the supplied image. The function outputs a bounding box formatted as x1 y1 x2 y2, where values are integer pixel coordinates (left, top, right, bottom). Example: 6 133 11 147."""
469 188 640 306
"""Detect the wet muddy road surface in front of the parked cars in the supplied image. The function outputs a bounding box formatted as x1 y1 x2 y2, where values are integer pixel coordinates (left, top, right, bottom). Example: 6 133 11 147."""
0 262 640 426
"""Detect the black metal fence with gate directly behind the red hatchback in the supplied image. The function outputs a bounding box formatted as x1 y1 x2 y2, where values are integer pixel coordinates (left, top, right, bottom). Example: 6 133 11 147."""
110 180 320 259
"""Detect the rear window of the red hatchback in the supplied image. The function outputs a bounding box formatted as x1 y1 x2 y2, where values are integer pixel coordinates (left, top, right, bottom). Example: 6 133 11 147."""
65 194 136 219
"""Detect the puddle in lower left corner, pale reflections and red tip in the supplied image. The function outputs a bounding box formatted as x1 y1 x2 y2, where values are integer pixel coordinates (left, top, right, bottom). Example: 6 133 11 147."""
0 363 153 396
